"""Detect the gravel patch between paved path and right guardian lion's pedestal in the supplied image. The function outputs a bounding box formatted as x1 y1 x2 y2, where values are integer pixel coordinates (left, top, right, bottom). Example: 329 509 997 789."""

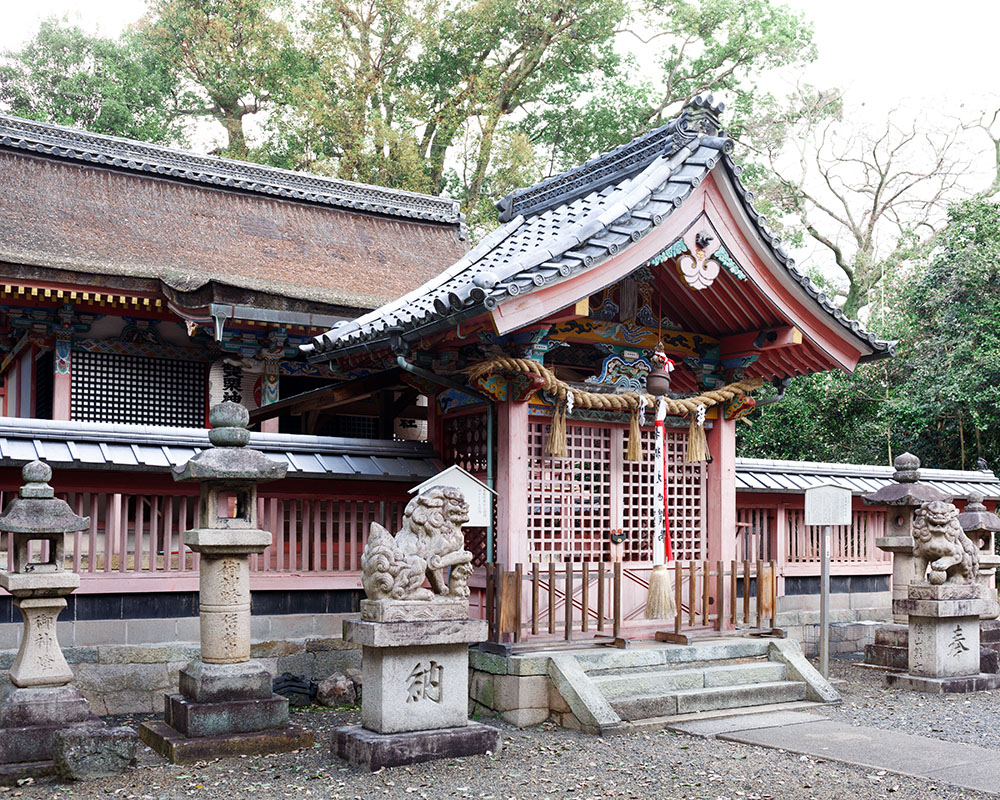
822 659 1000 750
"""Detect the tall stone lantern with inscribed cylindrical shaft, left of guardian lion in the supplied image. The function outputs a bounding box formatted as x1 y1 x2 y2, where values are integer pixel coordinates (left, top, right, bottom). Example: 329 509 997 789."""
139 401 313 763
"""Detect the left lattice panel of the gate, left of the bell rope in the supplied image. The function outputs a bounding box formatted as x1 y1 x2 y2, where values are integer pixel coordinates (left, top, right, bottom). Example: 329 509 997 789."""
527 421 615 561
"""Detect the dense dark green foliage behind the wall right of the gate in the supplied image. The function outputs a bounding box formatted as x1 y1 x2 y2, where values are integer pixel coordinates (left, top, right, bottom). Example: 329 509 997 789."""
740 198 1000 469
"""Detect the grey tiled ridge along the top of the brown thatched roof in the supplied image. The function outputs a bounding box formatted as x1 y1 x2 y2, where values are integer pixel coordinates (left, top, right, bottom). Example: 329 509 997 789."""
0 114 462 223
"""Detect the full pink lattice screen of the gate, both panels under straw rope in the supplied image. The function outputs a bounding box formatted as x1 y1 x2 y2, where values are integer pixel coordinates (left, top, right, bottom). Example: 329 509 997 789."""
527 420 705 563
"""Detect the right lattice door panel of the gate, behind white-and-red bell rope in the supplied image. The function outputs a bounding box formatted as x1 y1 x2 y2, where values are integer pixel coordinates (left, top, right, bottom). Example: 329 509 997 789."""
619 428 705 561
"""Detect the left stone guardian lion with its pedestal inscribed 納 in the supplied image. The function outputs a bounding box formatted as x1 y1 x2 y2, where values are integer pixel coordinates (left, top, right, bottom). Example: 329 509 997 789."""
331 487 500 770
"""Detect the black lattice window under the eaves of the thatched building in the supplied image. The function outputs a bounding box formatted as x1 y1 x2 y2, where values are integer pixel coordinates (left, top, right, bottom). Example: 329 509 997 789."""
70 350 208 428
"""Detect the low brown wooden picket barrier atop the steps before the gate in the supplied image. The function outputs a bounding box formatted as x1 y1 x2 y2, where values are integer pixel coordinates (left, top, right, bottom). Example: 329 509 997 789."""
485 561 778 644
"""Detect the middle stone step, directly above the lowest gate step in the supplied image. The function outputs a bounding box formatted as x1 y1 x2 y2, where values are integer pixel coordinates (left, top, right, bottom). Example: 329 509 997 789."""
590 661 786 700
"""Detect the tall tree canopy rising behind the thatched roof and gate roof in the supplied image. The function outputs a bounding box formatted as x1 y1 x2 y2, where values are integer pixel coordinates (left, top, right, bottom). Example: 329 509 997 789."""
4 0 813 222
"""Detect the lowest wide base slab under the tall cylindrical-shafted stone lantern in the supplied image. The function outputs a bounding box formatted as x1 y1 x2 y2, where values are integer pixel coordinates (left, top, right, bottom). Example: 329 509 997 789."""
139 722 313 764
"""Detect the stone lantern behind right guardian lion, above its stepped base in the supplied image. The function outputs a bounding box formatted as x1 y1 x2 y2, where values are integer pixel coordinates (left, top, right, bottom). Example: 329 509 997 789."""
861 453 951 624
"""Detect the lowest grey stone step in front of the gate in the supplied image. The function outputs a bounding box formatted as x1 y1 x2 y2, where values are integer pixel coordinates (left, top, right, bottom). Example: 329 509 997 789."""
611 681 806 722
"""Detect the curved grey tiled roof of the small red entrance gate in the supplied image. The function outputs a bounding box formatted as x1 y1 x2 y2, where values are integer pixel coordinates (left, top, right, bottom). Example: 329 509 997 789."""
303 97 894 360
